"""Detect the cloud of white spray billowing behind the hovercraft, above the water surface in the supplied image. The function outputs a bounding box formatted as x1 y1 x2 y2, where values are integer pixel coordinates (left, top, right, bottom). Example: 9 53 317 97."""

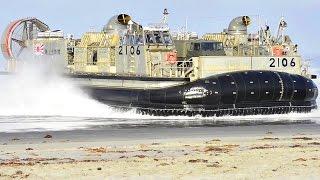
0 51 112 117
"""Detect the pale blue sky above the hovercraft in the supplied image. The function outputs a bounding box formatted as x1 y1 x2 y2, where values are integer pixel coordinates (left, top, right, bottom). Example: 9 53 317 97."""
0 0 320 67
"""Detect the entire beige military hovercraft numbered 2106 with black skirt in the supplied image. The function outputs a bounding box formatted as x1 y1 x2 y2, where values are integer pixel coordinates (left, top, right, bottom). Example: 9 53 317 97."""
1 9 318 116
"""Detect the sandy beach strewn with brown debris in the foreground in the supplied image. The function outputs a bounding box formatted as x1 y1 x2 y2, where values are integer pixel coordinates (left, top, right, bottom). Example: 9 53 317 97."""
0 124 320 179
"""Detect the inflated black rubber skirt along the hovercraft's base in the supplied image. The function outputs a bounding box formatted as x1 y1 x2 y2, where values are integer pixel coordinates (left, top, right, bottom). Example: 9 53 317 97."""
84 71 318 116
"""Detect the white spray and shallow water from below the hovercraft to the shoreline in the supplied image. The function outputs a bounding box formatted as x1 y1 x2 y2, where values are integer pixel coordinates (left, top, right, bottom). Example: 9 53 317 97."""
0 54 320 132
